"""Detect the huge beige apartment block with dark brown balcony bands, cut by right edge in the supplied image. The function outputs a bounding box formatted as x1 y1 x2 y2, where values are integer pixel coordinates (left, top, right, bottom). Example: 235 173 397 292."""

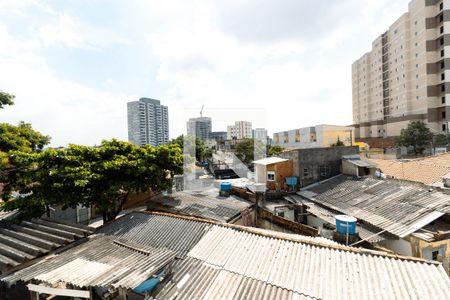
352 0 450 138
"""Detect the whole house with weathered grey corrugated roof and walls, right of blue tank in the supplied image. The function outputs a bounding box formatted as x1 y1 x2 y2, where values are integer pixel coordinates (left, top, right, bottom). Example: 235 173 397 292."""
298 175 450 275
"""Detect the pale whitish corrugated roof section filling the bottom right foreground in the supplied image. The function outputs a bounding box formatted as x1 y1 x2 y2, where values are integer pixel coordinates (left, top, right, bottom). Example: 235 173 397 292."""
156 221 450 300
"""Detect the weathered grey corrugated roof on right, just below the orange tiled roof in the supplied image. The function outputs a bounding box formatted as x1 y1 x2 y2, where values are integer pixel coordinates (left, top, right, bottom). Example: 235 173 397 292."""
298 175 450 237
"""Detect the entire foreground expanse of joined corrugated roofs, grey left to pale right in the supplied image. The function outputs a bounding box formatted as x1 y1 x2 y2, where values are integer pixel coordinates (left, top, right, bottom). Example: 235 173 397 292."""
3 213 450 299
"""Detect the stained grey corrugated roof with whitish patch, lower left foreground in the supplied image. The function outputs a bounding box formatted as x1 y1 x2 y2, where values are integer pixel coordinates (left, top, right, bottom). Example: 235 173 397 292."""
2 236 175 289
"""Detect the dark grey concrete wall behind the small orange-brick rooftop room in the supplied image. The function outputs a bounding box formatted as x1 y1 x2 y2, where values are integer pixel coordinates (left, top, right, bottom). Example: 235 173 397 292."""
280 146 359 186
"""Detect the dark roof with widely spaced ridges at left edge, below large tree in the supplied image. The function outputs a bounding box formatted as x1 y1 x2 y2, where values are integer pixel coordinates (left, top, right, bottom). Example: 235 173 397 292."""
0 219 93 273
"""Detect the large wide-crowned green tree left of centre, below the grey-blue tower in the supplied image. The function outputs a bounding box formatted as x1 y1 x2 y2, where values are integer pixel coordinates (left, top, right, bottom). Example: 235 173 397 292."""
3 140 182 222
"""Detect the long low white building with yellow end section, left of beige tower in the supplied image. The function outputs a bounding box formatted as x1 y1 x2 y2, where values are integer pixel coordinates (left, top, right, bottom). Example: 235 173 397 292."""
273 125 355 149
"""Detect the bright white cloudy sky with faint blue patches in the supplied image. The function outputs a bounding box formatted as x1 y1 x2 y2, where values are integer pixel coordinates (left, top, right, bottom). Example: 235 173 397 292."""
0 0 408 147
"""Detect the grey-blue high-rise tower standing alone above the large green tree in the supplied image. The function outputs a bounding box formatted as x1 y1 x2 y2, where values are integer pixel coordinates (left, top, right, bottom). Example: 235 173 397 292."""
127 98 169 147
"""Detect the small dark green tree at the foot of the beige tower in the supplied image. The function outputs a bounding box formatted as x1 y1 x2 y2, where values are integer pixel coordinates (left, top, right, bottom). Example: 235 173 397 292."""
397 121 433 155
